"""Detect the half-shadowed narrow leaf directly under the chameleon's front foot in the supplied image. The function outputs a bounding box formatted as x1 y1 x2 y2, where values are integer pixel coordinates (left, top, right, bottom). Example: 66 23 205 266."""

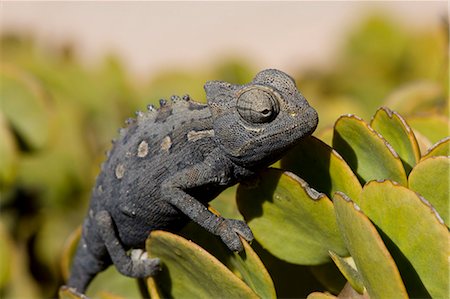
181 222 276 298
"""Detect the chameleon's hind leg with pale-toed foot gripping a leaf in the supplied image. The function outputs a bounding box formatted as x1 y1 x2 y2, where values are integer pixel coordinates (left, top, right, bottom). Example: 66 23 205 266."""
95 210 160 278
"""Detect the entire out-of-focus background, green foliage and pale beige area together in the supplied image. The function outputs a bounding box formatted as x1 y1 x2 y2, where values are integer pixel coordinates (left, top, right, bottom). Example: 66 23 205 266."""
0 1 449 298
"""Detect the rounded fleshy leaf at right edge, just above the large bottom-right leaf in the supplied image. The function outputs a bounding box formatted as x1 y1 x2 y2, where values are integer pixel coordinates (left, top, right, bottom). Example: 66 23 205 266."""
408 156 450 226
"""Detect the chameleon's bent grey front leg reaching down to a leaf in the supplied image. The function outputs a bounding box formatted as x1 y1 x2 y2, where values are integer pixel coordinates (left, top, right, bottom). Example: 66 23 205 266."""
162 159 253 252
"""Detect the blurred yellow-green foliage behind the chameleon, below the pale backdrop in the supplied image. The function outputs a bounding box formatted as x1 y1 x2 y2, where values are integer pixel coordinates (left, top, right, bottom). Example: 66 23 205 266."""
0 12 449 298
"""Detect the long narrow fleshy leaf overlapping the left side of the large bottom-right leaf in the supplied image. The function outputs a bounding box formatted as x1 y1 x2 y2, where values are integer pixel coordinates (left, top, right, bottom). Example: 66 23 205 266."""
334 192 408 298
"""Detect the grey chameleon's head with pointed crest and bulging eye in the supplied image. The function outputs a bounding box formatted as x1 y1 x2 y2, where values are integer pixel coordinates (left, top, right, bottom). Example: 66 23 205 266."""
205 69 318 167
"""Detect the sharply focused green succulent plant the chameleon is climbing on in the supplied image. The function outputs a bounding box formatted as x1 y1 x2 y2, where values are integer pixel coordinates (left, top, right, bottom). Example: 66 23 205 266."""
61 107 450 298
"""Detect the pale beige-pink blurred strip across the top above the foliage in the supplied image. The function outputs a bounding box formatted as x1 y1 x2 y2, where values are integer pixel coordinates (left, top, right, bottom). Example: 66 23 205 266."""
0 1 448 76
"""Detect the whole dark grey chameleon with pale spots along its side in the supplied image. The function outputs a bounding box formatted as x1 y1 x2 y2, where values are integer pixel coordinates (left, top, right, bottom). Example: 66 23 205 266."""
67 69 318 293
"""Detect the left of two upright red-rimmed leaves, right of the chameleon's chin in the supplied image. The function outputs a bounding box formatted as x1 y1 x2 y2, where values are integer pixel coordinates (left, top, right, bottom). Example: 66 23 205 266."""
333 115 407 186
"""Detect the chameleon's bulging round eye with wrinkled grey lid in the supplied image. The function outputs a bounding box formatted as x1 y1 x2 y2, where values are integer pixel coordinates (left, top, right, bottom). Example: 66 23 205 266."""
237 87 280 124
